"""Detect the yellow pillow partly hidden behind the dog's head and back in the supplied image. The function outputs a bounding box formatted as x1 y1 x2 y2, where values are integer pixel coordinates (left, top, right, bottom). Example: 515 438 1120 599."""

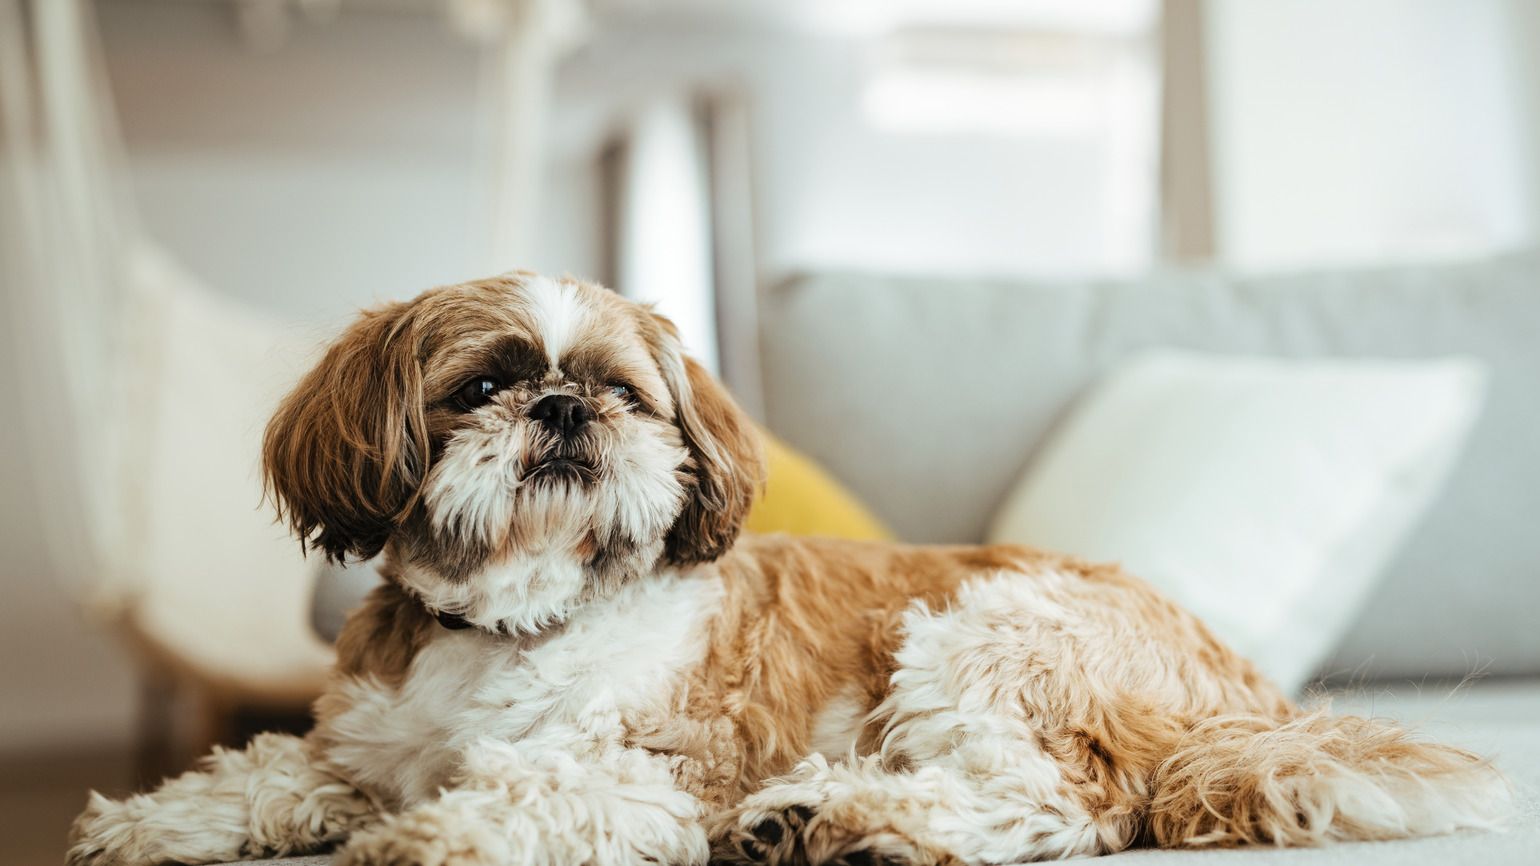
744 431 893 541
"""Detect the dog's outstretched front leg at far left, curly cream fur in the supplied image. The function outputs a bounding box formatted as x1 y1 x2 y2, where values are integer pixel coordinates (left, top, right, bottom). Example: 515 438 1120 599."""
66 733 374 866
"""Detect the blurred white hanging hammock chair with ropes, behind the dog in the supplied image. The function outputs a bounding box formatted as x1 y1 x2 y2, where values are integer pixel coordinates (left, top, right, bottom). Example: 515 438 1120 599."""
0 0 571 707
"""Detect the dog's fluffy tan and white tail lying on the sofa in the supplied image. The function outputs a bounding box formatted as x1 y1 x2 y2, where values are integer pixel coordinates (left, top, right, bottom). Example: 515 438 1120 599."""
1149 710 1512 848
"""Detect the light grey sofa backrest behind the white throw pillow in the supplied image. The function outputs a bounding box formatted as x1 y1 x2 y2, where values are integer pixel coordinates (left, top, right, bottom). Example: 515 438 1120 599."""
761 246 1540 676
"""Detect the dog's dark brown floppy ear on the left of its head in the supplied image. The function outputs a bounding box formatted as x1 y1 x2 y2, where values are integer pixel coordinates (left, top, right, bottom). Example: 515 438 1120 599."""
262 304 430 562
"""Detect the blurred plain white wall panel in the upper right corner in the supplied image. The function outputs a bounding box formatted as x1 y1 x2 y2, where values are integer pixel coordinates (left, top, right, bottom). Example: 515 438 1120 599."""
1207 0 1540 270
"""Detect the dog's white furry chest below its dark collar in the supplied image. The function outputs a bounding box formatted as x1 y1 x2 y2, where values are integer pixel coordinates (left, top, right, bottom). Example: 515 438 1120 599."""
317 575 721 807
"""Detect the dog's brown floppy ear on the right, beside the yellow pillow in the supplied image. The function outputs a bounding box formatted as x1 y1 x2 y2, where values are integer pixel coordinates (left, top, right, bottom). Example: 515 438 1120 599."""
642 310 765 566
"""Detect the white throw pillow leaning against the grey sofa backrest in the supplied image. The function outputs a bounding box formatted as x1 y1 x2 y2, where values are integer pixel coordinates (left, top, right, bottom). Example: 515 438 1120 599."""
990 351 1486 692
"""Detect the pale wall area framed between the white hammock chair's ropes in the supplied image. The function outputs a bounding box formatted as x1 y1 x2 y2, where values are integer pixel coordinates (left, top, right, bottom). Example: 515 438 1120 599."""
100 2 588 317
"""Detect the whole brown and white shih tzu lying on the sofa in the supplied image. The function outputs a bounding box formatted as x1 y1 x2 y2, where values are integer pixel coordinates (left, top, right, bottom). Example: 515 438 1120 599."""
68 273 1509 866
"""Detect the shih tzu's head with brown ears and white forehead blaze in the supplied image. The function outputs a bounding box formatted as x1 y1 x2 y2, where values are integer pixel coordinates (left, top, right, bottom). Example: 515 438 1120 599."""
263 274 762 630
